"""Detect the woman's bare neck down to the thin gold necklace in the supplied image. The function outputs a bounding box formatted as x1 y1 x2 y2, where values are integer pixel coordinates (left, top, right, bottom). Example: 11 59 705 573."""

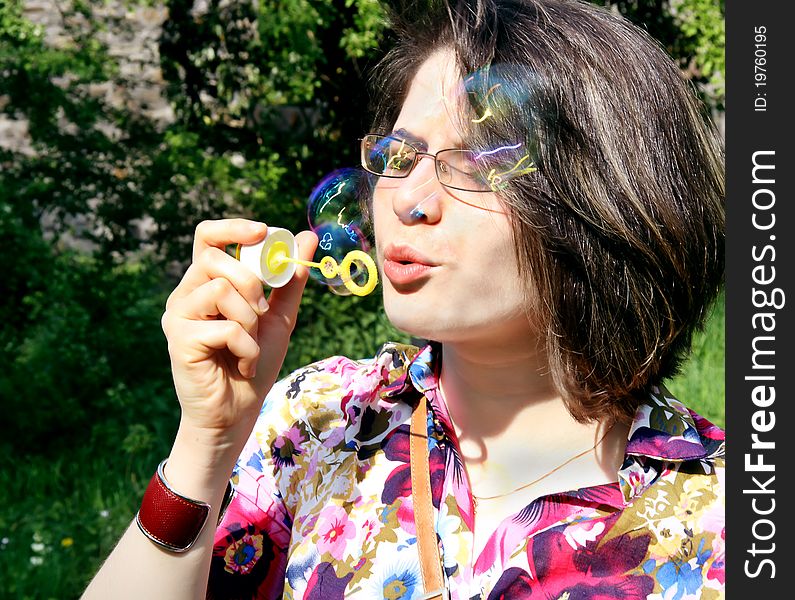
440 343 627 496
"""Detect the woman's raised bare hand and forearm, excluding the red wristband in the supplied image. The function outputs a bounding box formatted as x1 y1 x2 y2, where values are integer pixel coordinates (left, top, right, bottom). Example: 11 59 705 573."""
84 219 317 600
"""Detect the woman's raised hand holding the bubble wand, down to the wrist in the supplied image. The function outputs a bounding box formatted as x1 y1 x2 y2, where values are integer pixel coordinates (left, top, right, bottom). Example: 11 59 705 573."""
162 219 317 446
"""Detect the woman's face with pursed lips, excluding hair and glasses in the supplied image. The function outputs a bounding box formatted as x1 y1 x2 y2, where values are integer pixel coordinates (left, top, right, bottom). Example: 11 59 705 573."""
373 50 530 343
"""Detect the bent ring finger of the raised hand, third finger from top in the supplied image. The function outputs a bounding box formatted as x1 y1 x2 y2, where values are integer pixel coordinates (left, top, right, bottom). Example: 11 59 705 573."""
172 277 259 339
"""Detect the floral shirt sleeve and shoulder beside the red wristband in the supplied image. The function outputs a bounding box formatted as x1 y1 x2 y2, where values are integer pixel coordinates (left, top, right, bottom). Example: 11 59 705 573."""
207 354 398 600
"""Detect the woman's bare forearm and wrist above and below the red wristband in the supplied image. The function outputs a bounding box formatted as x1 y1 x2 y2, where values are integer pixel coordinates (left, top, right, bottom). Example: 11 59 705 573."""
83 428 244 600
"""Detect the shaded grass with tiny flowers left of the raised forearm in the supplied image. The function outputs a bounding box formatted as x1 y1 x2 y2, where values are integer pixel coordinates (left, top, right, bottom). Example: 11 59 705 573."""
0 444 162 600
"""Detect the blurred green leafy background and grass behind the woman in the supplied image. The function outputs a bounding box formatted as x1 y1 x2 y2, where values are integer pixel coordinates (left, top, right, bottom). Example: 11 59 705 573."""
0 0 725 600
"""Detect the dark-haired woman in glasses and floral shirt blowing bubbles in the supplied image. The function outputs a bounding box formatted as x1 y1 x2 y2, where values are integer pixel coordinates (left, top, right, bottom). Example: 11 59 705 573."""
86 0 724 599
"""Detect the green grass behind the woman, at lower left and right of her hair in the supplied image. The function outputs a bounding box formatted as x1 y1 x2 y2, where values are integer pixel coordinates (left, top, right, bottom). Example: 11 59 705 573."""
0 297 725 600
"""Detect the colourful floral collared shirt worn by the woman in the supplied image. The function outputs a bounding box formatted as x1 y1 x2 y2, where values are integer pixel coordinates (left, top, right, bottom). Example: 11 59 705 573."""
208 344 725 600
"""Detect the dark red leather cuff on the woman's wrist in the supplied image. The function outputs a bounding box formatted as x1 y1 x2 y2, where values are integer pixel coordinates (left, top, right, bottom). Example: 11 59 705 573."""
135 460 210 552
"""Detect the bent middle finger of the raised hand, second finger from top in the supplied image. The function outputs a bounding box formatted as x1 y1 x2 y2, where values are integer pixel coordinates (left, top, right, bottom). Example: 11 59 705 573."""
166 247 268 315
